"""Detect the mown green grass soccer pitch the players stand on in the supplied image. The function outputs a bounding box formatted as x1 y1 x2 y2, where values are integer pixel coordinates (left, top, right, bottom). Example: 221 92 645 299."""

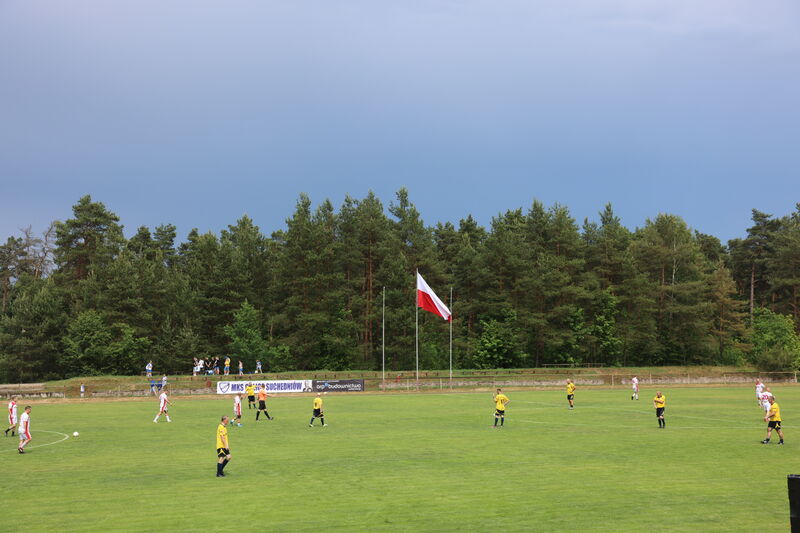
0 386 800 532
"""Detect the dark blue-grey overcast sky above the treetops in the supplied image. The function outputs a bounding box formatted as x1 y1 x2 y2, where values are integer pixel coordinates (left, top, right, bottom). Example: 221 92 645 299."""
0 0 800 242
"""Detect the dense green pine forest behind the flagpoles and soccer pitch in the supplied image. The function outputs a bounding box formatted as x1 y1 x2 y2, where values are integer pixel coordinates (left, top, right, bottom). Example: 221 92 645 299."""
0 189 800 382
